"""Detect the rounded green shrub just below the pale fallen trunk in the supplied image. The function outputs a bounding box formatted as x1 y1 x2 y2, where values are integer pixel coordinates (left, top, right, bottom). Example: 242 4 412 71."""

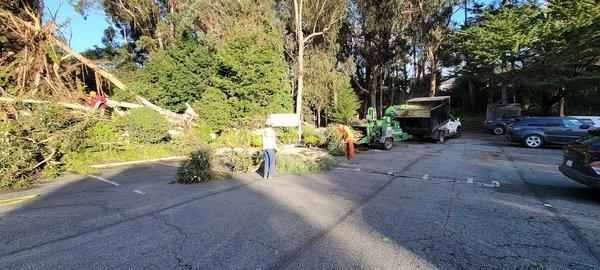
118 107 169 143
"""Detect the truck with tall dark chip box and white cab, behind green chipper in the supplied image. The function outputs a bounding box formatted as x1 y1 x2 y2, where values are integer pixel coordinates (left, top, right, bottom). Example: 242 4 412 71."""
385 96 461 143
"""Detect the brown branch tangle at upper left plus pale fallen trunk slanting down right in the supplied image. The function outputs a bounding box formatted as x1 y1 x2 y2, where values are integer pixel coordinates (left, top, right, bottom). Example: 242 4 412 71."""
0 8 198 128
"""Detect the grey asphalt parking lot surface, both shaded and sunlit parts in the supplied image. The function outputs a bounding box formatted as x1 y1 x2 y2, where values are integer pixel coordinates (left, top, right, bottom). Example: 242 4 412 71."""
0 129 600 269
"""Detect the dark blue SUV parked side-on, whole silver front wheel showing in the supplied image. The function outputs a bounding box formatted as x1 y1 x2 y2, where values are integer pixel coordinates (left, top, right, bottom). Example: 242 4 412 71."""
506 117 591 148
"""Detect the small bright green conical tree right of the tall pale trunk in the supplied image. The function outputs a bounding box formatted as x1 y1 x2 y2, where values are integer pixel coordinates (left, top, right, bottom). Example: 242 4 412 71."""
327 83 360 124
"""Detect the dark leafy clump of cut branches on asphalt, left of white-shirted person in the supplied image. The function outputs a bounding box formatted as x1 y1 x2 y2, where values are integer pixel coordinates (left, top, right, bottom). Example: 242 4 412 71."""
172 148 216 184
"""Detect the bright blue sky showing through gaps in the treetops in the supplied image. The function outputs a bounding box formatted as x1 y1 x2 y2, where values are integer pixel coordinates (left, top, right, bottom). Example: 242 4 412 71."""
44 0 498 52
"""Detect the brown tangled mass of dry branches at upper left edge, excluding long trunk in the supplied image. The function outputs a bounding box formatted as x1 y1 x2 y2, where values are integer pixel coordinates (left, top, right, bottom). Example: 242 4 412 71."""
0 9 81 101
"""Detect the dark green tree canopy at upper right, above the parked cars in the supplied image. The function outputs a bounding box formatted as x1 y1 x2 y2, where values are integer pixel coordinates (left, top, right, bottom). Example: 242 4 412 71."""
455 0 600 115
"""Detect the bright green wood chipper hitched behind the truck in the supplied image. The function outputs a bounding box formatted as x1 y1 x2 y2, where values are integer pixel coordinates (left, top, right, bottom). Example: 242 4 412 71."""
352 107 410 150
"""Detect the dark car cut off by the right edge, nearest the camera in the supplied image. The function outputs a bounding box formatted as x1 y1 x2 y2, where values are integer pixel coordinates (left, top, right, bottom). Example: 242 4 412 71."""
558 129 600 188
